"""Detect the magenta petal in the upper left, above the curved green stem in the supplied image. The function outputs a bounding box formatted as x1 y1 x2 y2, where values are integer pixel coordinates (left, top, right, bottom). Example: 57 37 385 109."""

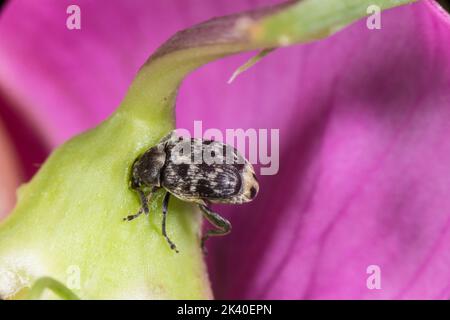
0 0 276 146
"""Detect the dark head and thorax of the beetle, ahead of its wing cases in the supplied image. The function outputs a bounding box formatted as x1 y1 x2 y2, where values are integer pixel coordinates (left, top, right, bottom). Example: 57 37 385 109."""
131 144 166 191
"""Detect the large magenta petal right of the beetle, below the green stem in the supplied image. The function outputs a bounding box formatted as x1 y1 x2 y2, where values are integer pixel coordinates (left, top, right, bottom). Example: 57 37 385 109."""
198 1 450 299
